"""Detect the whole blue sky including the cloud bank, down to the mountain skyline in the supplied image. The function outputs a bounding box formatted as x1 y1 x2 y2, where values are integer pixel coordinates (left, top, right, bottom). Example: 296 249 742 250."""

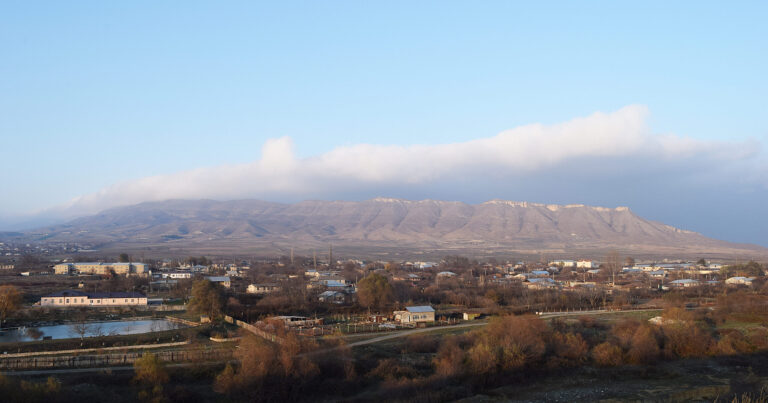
0 0 768 246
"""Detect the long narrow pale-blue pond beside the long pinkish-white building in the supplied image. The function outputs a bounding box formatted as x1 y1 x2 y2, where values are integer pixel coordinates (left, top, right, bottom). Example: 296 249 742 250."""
0 319 187 343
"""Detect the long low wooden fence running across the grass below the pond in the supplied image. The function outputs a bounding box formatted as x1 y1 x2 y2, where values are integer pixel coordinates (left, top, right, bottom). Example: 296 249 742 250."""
0 348 232 370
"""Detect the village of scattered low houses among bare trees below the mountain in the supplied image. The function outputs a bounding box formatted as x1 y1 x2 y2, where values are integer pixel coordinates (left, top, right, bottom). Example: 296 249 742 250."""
0 251 765 332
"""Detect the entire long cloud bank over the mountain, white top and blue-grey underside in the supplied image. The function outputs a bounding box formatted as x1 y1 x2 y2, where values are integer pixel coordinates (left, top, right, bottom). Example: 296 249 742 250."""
4 105 768 246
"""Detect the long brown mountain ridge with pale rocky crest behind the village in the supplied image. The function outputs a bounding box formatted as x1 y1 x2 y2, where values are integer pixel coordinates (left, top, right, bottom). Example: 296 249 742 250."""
3 197 768 256
